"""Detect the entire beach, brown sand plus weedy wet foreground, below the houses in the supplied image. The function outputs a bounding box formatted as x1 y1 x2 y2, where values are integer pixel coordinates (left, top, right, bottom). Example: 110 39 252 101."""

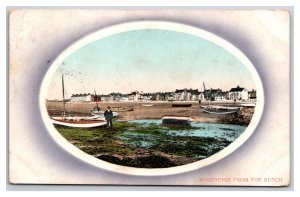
46 102 254 168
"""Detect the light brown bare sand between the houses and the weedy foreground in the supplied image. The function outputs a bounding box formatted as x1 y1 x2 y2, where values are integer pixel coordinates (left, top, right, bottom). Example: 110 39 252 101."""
46 102 253 123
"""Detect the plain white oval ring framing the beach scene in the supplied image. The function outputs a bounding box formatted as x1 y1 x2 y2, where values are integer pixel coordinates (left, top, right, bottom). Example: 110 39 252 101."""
40 21 264 176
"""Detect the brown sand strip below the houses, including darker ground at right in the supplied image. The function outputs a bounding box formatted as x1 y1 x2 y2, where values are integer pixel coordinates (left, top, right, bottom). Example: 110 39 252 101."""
46 102 254 125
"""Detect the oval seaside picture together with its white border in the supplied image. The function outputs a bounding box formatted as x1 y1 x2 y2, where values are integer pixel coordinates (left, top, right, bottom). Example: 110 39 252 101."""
40 21 264 176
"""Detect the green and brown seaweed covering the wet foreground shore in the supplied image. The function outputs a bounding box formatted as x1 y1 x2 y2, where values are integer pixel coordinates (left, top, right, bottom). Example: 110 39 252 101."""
55 121 230 168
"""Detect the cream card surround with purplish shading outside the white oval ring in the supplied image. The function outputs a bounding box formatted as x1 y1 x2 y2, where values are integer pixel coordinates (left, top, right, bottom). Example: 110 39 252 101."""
9 9 290 186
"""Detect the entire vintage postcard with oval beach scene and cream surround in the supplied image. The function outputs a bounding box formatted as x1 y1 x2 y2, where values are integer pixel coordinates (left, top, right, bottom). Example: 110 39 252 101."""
9 9 290 186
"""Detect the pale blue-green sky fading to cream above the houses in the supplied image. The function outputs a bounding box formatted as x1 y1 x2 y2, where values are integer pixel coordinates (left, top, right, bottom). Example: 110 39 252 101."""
47 29 256 99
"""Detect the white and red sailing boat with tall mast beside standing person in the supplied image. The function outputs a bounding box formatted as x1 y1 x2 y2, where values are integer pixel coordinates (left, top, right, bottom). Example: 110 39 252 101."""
51 75 106 128
